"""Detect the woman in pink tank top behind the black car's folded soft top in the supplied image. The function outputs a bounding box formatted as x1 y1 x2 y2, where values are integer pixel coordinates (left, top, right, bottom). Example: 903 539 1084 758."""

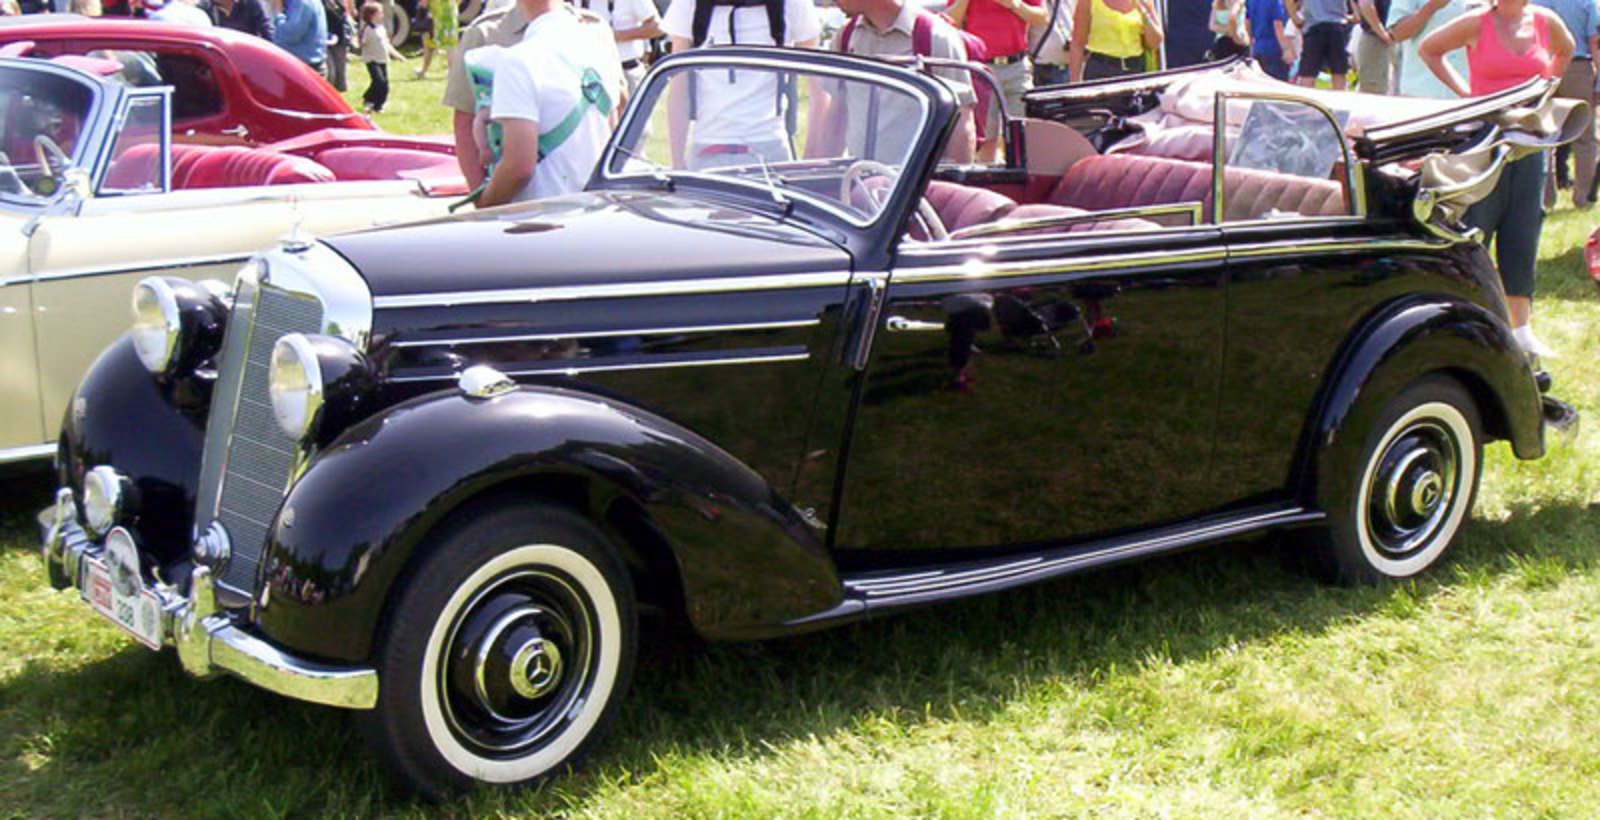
1416 0 1574 356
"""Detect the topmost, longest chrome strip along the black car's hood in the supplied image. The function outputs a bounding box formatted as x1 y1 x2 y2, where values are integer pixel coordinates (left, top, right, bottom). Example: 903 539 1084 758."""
373 271 850 311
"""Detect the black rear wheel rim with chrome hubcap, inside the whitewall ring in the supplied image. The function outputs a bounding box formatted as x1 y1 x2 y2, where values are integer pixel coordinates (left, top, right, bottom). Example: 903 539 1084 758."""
1366 420 1461 557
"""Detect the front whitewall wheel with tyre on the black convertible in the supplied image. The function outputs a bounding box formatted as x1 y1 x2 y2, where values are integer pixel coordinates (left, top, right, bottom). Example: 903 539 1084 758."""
357 504 637 798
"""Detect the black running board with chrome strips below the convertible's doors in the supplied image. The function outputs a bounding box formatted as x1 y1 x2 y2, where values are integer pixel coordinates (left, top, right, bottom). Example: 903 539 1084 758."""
784 508 1326 631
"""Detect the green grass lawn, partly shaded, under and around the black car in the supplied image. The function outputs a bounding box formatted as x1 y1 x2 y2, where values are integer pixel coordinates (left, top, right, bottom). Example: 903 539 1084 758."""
0 75 1600 818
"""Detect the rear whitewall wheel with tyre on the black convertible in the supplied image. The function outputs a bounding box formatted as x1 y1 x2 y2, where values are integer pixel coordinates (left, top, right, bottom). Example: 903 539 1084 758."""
1317 376 1483 583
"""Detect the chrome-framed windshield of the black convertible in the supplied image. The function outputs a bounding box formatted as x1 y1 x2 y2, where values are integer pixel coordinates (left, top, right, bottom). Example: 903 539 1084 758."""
605 62 928 224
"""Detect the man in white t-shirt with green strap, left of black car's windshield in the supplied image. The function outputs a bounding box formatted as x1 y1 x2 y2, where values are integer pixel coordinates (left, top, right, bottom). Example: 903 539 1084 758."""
478 0 624 208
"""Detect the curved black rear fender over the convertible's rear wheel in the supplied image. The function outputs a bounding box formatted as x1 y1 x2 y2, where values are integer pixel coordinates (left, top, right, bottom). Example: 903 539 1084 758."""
1301 295 1544 509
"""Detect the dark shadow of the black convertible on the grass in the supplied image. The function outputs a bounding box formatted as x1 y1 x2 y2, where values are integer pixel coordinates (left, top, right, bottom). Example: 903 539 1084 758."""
0 504 1600 815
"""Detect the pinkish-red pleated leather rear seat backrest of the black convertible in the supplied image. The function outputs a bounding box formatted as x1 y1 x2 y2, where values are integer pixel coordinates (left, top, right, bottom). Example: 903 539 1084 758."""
1048 154 1349 221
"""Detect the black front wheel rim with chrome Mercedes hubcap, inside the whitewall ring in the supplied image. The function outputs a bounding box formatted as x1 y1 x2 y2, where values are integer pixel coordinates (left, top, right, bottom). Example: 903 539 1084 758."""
438 569 600 759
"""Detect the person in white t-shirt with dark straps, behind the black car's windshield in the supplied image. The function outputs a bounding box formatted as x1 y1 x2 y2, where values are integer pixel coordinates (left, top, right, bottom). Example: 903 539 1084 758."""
661 0 822 170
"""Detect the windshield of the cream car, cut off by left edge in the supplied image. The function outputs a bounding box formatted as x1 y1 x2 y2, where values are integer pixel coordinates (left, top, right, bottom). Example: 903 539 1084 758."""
0 67 94 199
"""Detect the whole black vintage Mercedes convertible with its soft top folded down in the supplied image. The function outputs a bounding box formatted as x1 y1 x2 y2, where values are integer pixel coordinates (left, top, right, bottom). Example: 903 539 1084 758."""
45 50 1574 794
